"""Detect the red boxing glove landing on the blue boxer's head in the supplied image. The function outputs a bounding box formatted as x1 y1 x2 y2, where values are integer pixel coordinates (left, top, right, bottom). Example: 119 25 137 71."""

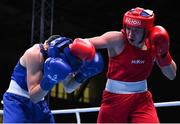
70 38 96 61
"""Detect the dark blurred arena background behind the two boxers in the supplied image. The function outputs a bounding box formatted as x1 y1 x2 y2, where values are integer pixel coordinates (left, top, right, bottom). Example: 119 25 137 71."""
0 0 180 123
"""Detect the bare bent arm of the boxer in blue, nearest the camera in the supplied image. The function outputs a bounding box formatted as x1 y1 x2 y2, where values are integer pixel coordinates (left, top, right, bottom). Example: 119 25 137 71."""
24 47 48 103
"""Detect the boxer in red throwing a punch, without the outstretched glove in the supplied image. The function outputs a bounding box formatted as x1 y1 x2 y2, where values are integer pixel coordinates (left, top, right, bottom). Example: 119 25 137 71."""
74 7 177 123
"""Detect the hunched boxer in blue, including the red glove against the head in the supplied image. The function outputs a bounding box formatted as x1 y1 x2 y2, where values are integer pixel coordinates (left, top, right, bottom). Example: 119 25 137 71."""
3 35 103 123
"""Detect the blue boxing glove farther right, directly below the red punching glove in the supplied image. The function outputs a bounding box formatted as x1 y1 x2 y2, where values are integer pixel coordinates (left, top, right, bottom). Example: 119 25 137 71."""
75 53 104 83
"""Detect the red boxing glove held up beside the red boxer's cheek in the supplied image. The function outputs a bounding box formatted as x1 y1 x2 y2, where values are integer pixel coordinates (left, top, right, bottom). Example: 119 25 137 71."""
149 26 172 67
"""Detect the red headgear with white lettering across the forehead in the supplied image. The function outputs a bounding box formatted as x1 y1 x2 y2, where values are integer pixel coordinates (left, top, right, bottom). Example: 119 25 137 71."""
123 7 154 31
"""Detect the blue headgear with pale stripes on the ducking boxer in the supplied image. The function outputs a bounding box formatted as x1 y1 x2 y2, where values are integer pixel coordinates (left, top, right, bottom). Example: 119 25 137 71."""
47 37 72 57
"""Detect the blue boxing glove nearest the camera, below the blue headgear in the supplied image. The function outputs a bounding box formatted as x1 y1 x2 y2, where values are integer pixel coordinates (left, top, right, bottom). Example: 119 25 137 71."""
40 57 72 91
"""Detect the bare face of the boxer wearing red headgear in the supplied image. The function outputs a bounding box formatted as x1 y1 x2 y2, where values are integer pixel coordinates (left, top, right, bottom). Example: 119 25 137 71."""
126 27 145 46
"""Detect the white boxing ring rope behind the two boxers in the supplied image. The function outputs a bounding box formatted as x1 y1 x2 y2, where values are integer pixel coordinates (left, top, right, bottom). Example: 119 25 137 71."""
0 101 180 124
